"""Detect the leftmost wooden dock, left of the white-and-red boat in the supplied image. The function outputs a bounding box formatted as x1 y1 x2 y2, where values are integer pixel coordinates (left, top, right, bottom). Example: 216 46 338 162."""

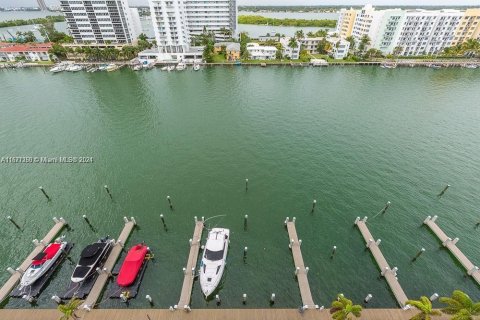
0 218 67 302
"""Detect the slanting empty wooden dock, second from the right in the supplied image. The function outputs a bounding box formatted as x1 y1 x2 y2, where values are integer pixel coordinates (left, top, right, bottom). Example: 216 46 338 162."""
355 217 408 308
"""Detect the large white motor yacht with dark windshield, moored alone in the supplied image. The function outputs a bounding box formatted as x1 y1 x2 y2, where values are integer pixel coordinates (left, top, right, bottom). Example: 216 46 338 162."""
200 228 230 298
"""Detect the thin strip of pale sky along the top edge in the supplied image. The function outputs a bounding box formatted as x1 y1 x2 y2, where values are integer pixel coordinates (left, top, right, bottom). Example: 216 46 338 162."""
0 0 480 7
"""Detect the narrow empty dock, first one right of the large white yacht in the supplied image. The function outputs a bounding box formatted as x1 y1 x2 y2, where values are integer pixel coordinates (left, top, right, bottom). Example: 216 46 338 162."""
285 218 317 309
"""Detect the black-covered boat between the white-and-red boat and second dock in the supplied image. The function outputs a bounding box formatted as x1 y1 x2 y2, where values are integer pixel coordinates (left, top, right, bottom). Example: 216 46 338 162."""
71 239 113 283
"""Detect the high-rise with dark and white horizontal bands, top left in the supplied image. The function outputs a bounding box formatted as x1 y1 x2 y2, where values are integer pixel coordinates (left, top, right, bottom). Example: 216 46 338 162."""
60 0 141 44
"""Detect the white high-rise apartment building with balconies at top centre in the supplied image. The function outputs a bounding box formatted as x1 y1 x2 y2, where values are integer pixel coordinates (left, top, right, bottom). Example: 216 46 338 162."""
149 0 237 52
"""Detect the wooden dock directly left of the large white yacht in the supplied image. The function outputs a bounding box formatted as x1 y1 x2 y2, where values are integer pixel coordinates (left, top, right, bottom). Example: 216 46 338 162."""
177 221 203 309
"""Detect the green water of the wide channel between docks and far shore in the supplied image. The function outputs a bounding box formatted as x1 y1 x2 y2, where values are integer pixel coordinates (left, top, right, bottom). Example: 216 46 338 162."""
0 67 480 308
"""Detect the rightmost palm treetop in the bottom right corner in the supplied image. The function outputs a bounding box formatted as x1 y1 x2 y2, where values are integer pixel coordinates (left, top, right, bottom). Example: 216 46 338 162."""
440 290 480 320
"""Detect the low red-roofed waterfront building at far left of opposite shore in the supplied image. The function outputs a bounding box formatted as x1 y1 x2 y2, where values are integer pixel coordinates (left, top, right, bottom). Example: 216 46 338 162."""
0 43 52 62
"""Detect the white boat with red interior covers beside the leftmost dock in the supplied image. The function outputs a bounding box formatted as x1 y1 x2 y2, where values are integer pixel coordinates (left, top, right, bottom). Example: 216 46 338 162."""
20 239 67 287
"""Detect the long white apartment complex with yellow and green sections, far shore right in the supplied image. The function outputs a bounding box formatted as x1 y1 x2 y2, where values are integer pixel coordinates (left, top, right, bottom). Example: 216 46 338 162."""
336 5 480 55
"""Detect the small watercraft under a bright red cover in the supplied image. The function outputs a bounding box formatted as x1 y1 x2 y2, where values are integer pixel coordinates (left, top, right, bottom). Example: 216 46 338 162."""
117 244 148 287
